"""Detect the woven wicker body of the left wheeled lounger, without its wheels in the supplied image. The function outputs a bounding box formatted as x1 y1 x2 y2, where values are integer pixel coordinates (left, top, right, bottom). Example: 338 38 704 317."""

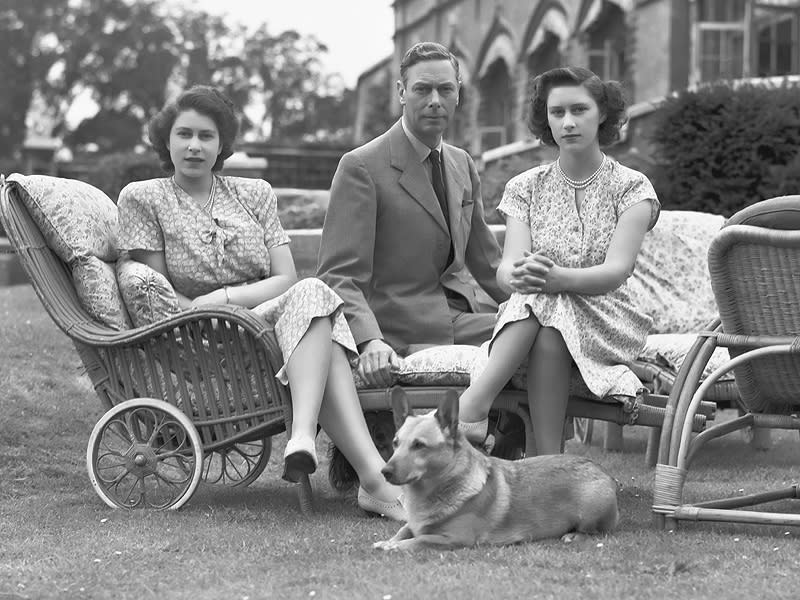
0 180 290 442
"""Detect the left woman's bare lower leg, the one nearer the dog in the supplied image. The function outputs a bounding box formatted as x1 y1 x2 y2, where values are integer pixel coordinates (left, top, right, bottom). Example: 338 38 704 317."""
319 343 400 502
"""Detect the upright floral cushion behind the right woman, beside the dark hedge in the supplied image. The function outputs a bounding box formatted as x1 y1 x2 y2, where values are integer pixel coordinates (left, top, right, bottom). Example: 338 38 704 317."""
630 210 725 333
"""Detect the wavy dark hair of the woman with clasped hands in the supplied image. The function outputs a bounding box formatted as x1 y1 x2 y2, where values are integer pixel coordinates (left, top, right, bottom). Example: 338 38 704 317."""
528 67 628 146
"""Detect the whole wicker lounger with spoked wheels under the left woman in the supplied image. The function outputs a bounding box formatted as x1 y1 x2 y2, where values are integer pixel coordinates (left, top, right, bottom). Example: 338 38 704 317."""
0 176 312 512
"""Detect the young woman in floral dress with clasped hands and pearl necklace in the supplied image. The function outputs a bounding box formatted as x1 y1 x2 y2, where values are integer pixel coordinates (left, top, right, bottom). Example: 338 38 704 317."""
460 67 660 454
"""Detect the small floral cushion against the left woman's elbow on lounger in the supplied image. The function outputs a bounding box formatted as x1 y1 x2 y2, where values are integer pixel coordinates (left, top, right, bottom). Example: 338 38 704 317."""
116 255 181 327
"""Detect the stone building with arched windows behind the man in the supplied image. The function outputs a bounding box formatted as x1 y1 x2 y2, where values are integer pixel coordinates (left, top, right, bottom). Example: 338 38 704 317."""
355 0 800 155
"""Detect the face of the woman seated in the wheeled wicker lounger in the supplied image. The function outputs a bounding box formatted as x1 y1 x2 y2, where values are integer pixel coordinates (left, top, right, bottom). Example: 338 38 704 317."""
169 110 222 179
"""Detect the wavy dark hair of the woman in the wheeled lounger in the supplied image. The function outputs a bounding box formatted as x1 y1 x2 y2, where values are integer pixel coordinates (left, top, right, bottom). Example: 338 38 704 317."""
147 85 239 173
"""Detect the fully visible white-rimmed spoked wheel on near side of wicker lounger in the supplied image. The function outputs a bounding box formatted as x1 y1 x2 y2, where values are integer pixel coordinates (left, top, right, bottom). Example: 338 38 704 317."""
86 398 203 510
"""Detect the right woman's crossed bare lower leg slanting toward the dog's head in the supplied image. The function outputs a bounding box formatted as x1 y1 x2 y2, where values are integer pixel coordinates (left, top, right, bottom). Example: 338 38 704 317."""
458 316 541 423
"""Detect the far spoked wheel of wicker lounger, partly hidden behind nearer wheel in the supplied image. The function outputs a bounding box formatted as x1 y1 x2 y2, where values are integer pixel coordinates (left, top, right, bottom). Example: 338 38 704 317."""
203 437 272 486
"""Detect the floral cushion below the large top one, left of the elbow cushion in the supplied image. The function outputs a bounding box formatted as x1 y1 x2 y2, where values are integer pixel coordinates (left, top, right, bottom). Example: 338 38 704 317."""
72 256 131 331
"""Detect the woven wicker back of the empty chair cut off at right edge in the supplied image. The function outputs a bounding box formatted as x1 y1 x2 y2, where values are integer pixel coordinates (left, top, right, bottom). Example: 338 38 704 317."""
708 196 800 412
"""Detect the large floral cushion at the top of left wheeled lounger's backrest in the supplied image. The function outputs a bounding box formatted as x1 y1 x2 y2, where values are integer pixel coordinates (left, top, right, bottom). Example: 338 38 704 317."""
8 173 117 266
